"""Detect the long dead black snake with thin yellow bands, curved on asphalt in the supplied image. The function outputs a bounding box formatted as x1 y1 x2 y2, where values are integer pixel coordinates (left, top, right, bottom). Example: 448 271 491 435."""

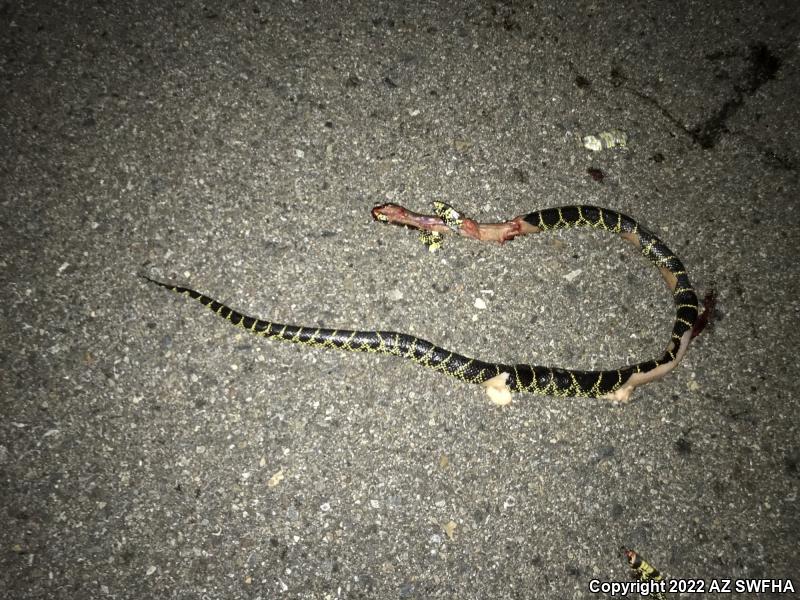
145 203 710 404
